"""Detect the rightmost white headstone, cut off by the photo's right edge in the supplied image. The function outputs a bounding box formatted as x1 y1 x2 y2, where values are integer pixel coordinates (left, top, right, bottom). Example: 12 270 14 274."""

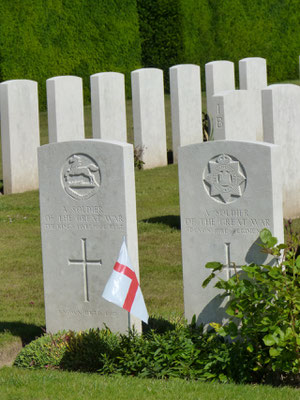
262 84 300 218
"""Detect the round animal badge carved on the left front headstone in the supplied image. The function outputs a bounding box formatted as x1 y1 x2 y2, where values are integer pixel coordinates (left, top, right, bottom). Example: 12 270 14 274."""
61 154 101 200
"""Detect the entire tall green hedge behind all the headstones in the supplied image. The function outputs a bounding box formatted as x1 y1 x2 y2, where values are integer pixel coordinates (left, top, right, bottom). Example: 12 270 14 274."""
0 0 300 108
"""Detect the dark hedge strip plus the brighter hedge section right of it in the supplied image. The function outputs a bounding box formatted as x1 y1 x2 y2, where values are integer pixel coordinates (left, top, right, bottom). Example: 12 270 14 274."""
137 0 300 88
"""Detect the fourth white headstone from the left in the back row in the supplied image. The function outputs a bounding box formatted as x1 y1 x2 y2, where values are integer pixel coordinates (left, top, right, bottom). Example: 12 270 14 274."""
131 68 167 169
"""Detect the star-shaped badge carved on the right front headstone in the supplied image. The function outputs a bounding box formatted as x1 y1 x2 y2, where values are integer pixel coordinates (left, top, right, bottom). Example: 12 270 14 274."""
203 154 247 204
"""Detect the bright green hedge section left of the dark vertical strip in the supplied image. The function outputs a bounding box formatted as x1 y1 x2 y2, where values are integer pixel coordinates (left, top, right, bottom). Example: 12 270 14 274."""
0 0 141 108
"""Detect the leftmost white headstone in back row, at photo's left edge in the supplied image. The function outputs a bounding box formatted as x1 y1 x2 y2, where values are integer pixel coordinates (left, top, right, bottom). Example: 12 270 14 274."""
0 80 40 194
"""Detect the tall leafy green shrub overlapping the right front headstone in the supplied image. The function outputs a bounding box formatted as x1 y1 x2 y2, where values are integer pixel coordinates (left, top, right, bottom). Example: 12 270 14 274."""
203 229 300 380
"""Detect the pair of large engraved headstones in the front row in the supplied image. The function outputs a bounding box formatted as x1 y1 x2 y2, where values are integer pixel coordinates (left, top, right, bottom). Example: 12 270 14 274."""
38 139 283 332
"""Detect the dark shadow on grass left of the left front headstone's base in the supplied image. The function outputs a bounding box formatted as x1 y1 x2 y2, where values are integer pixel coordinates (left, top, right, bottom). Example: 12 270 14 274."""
0 321 45 346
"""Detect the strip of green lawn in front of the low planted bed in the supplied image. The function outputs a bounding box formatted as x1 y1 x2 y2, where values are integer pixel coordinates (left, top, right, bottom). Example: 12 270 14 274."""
0 368 300 400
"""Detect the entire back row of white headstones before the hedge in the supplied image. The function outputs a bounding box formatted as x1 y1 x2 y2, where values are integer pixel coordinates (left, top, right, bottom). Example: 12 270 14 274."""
0 58 300 218
